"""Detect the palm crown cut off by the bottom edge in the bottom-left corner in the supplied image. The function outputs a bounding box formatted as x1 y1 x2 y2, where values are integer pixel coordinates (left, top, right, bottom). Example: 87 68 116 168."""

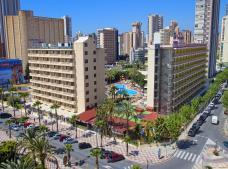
0 156 36 169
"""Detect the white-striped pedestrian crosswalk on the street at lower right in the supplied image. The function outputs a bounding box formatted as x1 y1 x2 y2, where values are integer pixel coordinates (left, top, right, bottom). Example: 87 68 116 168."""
173 150 201 163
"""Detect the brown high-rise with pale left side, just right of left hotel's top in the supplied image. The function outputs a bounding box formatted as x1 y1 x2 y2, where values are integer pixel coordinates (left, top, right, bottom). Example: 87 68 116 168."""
97 28 119 64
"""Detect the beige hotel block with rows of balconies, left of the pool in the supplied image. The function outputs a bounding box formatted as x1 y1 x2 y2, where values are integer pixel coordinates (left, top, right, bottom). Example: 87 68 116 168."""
28 36 105 116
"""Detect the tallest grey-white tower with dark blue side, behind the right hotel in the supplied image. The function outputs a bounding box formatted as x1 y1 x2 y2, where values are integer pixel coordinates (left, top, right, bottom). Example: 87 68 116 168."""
194 0 220 78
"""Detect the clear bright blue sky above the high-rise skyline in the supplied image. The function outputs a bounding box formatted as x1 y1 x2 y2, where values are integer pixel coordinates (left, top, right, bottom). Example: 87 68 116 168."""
21 0 228 35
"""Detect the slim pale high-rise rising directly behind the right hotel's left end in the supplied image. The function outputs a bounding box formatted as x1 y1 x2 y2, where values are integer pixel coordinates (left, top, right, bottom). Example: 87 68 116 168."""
148 15 163 45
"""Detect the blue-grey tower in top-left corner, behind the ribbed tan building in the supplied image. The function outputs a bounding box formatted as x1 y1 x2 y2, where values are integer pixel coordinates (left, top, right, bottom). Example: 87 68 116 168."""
0 0 20 55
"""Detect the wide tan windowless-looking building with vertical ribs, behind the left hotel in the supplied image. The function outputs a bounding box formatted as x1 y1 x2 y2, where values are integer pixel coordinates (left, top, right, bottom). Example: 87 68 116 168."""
4 11 64 70
